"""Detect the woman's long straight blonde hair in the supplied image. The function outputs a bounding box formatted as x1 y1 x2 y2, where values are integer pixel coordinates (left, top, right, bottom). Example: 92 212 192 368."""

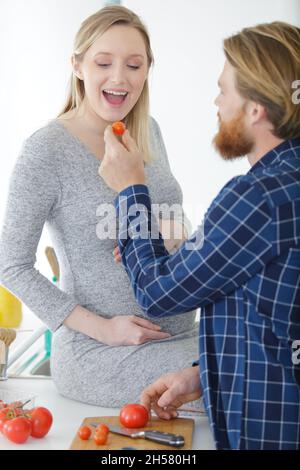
57 5 153 162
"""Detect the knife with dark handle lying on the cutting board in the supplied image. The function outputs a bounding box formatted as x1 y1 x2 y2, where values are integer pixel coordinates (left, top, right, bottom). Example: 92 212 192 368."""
89 423 184 447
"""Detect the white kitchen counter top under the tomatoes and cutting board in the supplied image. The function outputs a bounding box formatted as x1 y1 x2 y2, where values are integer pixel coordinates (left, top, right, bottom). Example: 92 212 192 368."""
0 378 215 450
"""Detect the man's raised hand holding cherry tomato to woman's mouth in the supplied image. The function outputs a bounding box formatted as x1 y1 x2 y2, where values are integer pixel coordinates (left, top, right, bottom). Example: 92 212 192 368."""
99 126 145 193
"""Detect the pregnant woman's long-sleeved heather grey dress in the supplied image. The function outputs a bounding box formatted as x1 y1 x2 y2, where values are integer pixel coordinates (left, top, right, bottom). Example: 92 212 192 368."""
0 119 198 407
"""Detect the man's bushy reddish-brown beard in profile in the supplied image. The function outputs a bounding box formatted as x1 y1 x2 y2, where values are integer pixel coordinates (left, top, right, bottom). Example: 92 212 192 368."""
213 109 254 160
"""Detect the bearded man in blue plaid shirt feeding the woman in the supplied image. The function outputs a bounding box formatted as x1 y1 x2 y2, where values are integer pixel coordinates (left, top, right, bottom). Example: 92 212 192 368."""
100 22 300 449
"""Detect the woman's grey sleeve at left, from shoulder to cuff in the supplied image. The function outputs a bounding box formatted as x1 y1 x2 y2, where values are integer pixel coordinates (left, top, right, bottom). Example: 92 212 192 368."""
0 135 78 331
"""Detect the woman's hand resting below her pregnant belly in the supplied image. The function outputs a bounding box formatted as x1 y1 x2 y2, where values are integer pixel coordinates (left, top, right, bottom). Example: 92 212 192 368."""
101 315 171 346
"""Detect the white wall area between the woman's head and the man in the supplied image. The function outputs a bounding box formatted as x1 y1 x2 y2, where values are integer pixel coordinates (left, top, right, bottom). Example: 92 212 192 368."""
123 0 300 228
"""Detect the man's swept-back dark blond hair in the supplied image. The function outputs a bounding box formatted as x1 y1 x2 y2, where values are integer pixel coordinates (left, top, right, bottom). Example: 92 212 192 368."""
224 21 300 140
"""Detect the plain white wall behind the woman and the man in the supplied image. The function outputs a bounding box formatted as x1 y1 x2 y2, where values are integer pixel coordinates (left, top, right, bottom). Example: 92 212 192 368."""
0 0 300 300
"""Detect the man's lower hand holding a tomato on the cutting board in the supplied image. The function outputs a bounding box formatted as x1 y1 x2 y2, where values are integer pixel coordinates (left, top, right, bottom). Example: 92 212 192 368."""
140 366 202 419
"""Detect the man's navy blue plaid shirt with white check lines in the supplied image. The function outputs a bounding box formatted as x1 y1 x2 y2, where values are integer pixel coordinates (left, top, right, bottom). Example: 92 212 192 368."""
116 139 300 449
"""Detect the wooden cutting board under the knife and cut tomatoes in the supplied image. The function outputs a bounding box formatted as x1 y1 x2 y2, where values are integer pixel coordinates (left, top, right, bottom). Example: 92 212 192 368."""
70 416 194 450
